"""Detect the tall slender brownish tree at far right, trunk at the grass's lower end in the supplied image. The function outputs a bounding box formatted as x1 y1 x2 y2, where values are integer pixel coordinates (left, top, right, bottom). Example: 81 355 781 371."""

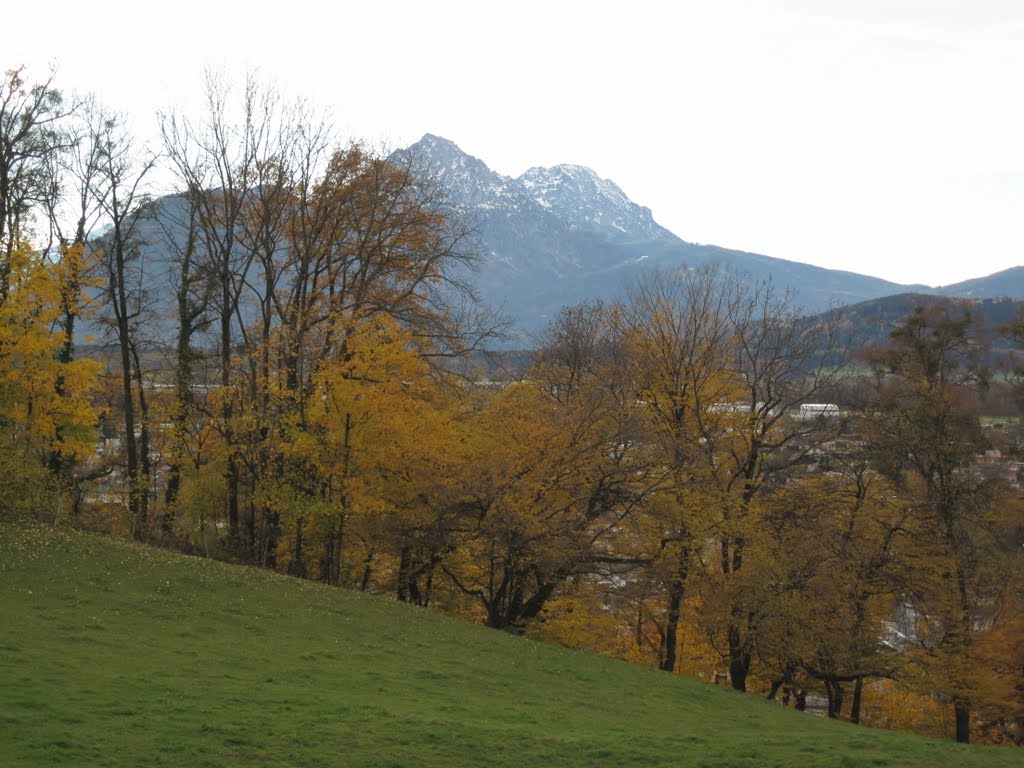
869 306 1002 741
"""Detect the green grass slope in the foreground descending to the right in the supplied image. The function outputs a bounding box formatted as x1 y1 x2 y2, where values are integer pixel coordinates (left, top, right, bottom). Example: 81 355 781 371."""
0 523 1024 768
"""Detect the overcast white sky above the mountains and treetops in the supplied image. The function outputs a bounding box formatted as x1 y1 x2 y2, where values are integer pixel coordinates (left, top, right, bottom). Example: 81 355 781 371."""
8 0 1024 285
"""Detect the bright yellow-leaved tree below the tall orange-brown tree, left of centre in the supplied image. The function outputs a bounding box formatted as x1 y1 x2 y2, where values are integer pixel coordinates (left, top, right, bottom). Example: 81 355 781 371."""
272 314 442 584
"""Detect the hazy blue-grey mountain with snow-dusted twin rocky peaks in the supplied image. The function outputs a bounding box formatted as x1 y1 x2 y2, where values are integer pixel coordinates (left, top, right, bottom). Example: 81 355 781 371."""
400 133 1024 330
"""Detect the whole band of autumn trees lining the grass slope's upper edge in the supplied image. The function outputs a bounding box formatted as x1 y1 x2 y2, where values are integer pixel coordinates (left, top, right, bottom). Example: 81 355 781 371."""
0 71 1024 742
